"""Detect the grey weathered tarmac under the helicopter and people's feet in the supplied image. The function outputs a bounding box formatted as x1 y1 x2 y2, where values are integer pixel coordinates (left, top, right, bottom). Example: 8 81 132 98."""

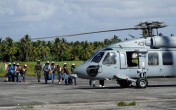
0 77 176 110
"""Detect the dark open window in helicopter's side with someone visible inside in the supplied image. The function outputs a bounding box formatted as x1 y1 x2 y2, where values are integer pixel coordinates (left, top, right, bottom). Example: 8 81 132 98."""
127 52 139 67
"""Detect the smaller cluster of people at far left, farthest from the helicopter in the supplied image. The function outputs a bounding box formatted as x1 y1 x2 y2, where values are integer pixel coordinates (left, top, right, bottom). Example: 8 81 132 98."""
6 63 27 82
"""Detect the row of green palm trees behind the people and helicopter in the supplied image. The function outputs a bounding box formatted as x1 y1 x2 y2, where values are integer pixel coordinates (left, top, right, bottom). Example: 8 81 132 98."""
0 35 121 62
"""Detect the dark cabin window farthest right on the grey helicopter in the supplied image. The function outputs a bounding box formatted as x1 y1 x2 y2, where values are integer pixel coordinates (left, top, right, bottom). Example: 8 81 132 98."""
162 52 173 65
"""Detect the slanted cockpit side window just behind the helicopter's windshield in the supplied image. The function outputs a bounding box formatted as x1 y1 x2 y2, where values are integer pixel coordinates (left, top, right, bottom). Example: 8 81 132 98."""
102 52 116 64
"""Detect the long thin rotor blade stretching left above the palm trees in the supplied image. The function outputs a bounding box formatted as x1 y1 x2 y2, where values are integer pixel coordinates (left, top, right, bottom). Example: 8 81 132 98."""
31 28 140 40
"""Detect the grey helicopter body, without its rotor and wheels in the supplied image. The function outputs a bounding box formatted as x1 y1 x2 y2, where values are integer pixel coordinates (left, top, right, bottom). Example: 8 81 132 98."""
75 36 176 80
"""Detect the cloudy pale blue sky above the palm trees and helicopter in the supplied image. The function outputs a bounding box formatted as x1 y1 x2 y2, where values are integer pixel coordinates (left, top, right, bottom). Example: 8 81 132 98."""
0 0 176 41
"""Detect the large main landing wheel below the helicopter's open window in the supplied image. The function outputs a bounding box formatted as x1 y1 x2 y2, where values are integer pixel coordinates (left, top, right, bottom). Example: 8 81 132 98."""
136 78 148 88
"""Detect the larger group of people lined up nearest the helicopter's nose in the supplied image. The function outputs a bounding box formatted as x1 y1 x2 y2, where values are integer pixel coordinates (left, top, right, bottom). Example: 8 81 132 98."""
34 60 77 85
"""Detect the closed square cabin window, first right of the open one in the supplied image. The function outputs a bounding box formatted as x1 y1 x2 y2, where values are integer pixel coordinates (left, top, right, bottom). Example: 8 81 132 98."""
148 52 159 65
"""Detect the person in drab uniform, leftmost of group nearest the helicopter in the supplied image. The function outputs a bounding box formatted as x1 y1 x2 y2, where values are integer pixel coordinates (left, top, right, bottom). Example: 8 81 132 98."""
34 60 42 82
